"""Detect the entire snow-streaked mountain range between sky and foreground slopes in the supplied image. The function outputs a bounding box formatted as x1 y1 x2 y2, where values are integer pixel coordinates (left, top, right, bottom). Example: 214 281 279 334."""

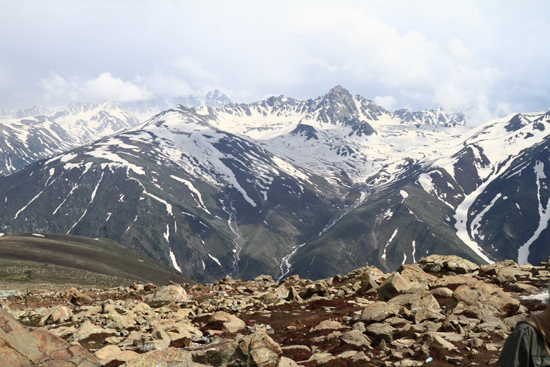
0 86 550 282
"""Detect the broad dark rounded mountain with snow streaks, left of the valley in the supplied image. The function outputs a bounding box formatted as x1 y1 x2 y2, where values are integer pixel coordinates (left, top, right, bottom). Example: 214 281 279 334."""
0 107 342 280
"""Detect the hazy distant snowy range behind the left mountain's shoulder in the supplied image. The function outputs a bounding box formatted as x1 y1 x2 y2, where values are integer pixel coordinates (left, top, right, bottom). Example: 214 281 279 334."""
0 90 231 175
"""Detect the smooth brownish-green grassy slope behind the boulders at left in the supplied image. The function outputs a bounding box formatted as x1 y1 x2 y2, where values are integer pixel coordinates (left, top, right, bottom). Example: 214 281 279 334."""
0 232 193 286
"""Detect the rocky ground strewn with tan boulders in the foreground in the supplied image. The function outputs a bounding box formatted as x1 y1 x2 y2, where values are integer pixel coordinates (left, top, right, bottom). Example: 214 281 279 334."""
0 255 550 367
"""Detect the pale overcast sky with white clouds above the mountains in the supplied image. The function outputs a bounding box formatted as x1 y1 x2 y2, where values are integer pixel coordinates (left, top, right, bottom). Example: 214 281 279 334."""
0 0 550 123
